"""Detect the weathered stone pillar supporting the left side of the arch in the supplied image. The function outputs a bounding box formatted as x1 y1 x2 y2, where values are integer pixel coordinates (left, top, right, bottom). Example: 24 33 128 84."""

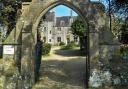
21 23 35 89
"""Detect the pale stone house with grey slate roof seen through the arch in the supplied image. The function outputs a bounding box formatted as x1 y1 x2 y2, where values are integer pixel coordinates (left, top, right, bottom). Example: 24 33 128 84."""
38 12 78 45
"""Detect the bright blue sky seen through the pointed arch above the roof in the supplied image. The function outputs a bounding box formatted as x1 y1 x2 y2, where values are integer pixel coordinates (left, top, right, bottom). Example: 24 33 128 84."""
50 5 77 17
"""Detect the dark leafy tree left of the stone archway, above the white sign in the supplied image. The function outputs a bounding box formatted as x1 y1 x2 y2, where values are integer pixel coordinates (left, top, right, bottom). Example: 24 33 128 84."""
0 0 21 38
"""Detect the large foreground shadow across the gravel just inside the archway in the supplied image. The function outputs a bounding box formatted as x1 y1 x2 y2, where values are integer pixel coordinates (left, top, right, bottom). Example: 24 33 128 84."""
41 58 85 87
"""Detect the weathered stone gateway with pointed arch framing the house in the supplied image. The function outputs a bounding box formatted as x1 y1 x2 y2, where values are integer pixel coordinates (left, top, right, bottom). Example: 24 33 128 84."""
0 0 118 89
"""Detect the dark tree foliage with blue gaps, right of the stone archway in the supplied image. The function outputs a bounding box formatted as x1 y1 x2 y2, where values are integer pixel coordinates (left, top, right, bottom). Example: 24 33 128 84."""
101 0 128 43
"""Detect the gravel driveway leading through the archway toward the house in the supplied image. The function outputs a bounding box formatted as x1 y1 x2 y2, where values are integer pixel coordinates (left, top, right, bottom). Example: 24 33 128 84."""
33 47 86 89
